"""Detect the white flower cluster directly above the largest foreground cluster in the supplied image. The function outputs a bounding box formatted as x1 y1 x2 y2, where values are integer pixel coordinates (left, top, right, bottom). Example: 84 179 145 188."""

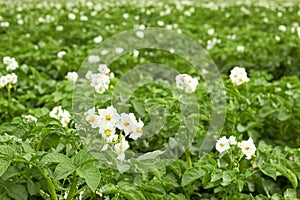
85 64 114 94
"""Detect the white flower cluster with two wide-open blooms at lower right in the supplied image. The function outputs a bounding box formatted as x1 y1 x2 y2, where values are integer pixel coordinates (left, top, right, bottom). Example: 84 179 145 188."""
216 136 256 160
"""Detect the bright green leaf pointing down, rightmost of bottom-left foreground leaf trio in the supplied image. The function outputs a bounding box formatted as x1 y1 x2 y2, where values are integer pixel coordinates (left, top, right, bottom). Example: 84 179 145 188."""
77 163 101 191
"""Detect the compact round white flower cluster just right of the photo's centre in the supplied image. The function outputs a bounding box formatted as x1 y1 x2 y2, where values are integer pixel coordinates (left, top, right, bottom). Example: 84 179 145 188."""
175 74 198 93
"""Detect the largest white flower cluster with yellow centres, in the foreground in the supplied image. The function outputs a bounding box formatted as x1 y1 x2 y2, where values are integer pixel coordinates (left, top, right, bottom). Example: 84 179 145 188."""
85 106 144 160
